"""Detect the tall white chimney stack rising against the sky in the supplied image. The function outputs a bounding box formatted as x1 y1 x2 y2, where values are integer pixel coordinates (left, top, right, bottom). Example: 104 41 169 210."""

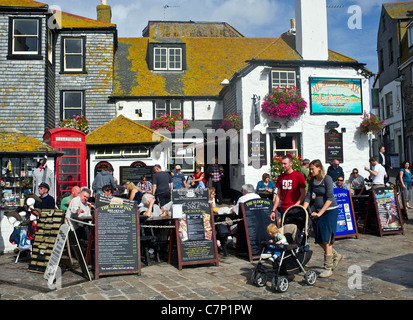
295 0 328 61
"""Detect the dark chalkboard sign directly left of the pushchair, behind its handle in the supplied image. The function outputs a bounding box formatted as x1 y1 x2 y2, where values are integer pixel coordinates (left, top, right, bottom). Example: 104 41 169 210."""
236 198 275 262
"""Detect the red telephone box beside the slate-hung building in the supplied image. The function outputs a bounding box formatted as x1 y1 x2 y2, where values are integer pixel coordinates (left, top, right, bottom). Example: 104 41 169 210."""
43 128 87 197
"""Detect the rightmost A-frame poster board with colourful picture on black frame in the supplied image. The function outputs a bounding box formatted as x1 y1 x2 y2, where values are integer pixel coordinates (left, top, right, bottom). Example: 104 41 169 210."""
363 188 404 236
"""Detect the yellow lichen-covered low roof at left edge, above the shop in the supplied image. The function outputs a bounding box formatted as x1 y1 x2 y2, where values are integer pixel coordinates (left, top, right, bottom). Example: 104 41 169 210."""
0 130 57 153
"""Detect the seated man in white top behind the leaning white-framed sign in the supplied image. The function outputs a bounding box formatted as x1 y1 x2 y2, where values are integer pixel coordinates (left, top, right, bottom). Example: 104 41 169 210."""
66 188 92 239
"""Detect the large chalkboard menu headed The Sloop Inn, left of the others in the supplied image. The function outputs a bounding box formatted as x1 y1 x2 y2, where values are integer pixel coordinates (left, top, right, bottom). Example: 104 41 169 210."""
95 195 141 279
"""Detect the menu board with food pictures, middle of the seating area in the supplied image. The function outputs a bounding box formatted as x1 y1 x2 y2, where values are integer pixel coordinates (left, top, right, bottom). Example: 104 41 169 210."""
172 189 219 269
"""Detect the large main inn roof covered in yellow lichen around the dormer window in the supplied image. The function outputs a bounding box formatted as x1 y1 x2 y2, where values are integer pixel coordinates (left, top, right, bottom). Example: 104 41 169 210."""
113 33 357 98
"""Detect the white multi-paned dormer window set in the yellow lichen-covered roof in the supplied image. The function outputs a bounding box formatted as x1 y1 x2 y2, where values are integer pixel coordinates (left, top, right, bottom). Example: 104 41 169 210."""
149 44 185 71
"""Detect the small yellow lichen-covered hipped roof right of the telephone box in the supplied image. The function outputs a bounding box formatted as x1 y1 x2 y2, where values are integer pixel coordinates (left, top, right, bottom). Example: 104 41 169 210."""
86 115 166 146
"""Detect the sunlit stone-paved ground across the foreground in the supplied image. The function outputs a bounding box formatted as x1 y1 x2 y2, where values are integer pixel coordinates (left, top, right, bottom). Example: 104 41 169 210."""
0 216 413 300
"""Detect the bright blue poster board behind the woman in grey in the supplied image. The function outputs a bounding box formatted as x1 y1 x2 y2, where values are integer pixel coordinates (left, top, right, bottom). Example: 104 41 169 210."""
334 188 359 239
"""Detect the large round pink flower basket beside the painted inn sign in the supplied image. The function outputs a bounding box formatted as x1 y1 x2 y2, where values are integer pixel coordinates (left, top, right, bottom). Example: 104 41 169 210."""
261 87 307 119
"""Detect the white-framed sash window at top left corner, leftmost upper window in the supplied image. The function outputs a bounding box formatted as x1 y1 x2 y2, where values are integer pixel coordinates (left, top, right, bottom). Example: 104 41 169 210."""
11 18 40 55
